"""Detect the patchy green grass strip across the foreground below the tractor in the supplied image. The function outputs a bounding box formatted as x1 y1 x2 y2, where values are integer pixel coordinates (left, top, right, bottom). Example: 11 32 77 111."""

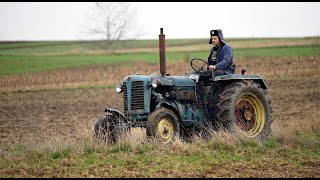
0 135 320 177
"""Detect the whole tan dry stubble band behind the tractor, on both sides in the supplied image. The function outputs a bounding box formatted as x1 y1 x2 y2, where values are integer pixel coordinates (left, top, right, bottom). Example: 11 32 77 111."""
0 57 320 92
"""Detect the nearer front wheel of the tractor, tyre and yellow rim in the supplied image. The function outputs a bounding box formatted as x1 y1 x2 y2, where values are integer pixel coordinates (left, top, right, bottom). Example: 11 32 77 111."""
146 108 180 144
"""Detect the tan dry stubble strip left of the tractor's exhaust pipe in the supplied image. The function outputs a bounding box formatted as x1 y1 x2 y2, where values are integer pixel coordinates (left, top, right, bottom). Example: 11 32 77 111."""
0 63 159 92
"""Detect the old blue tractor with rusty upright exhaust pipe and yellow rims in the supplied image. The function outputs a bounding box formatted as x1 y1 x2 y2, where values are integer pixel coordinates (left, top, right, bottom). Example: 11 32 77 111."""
94 28 272 143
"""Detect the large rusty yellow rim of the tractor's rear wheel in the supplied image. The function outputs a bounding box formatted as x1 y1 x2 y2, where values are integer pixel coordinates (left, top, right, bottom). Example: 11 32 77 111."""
235 93 266 138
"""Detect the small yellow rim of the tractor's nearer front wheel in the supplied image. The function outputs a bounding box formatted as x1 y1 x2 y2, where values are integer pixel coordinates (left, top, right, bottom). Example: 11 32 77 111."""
157 118 174 143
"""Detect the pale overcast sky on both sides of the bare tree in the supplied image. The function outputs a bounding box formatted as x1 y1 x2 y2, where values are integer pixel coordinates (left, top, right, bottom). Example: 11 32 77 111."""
0 2 320 41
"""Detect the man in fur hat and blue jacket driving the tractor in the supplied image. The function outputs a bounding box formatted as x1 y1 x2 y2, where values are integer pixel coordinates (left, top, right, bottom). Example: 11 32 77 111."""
206 29 235 76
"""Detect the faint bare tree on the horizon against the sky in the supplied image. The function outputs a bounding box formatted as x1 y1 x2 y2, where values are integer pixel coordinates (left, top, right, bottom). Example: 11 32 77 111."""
86 2 141 49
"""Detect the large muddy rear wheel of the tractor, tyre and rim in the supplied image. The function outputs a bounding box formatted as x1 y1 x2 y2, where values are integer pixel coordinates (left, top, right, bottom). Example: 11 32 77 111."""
216 80 272 143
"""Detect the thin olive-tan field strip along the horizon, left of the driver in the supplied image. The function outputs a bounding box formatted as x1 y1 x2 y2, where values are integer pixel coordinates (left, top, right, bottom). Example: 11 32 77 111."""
0 39 206 55
